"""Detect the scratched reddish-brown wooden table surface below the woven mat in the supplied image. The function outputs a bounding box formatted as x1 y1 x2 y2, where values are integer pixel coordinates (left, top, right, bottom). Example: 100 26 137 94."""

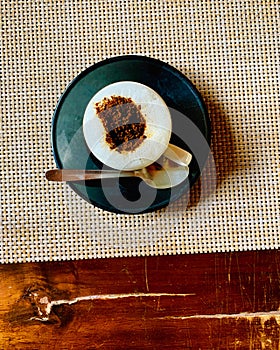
0 250 280 349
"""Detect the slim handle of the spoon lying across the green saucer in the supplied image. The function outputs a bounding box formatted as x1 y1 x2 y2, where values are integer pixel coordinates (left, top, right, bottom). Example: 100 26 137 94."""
45 169 136 182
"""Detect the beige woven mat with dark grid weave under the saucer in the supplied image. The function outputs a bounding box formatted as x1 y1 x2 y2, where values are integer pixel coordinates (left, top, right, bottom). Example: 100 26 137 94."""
0 0 280 263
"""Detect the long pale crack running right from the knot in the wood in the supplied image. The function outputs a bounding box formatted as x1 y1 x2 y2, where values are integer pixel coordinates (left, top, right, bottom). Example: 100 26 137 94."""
30 293 195 322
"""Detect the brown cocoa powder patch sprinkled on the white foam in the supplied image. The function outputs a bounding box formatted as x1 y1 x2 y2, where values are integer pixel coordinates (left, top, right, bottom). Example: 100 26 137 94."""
95 95 146 153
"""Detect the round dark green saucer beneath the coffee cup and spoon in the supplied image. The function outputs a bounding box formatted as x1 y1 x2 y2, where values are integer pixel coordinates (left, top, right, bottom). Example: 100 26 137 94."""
52 55 211 214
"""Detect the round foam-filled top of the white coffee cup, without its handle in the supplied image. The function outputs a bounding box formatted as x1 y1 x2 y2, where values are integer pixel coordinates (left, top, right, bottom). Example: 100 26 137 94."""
83 81 172 170
